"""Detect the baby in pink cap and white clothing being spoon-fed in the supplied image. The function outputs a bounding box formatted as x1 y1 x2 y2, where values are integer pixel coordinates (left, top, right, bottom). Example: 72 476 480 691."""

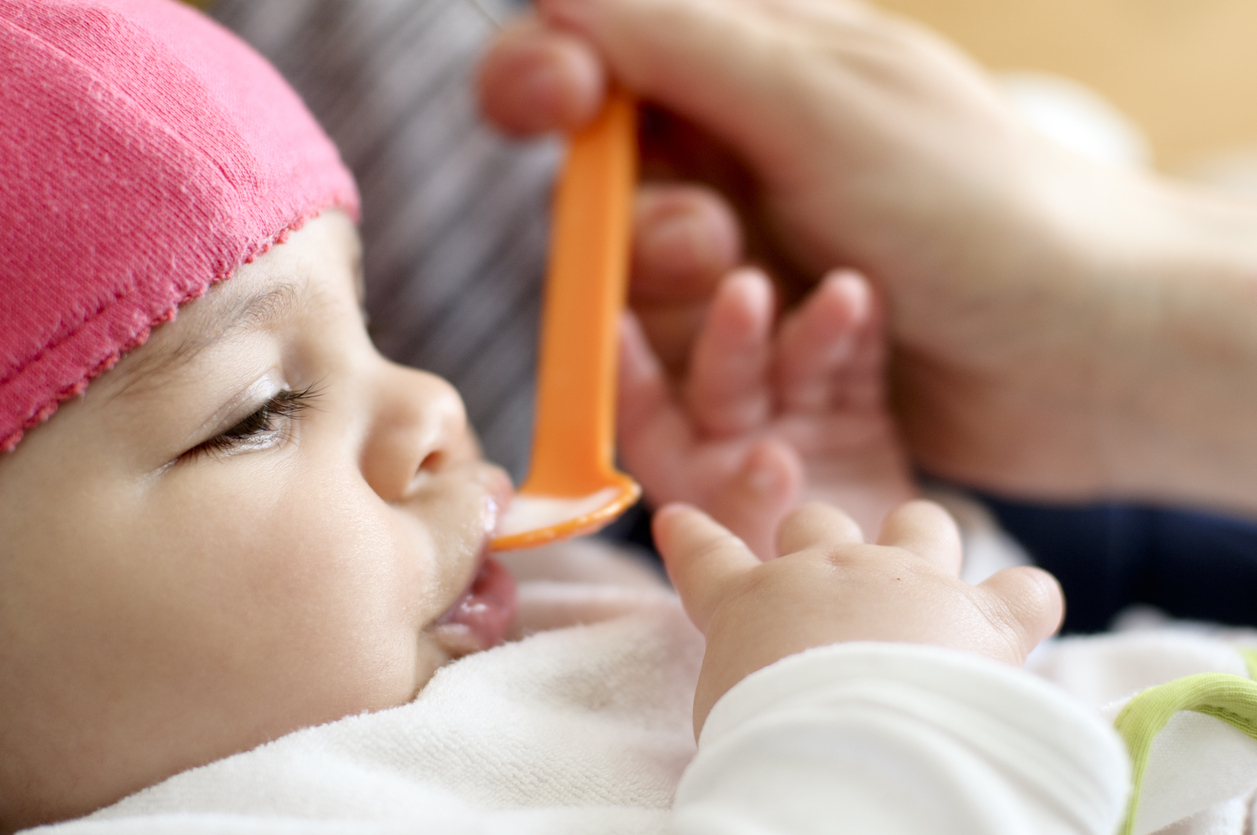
0 0 1226 832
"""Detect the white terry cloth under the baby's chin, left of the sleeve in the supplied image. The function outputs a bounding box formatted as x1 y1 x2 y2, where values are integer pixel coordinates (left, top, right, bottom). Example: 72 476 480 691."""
34 546 703 832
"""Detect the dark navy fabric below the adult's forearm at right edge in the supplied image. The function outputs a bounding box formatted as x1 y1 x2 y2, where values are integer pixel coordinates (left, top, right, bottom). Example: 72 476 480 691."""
983 495 1257 633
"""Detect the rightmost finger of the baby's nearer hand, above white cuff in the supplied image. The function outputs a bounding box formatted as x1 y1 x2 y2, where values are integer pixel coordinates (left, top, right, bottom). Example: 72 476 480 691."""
978 566 1065 665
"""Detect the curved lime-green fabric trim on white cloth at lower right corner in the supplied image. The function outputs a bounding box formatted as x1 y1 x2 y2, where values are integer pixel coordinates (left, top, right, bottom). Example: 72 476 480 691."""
1114 674 1257 835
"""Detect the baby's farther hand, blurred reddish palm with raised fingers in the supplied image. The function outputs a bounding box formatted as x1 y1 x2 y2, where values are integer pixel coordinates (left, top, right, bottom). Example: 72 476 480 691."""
618 269 915 558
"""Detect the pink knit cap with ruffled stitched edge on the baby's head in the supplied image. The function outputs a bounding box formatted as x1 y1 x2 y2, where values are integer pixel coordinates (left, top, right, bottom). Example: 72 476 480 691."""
0 0 358 450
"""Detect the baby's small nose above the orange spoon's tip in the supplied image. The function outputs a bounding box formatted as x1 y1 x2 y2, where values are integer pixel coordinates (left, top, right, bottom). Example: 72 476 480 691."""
362 363 475 502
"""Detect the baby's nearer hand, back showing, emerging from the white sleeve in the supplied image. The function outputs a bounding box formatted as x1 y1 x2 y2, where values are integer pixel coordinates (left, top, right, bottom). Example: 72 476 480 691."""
654 500 1065 736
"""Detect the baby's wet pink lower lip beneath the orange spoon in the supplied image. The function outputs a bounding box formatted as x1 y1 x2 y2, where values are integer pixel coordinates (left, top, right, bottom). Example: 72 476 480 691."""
430 555 519 659
